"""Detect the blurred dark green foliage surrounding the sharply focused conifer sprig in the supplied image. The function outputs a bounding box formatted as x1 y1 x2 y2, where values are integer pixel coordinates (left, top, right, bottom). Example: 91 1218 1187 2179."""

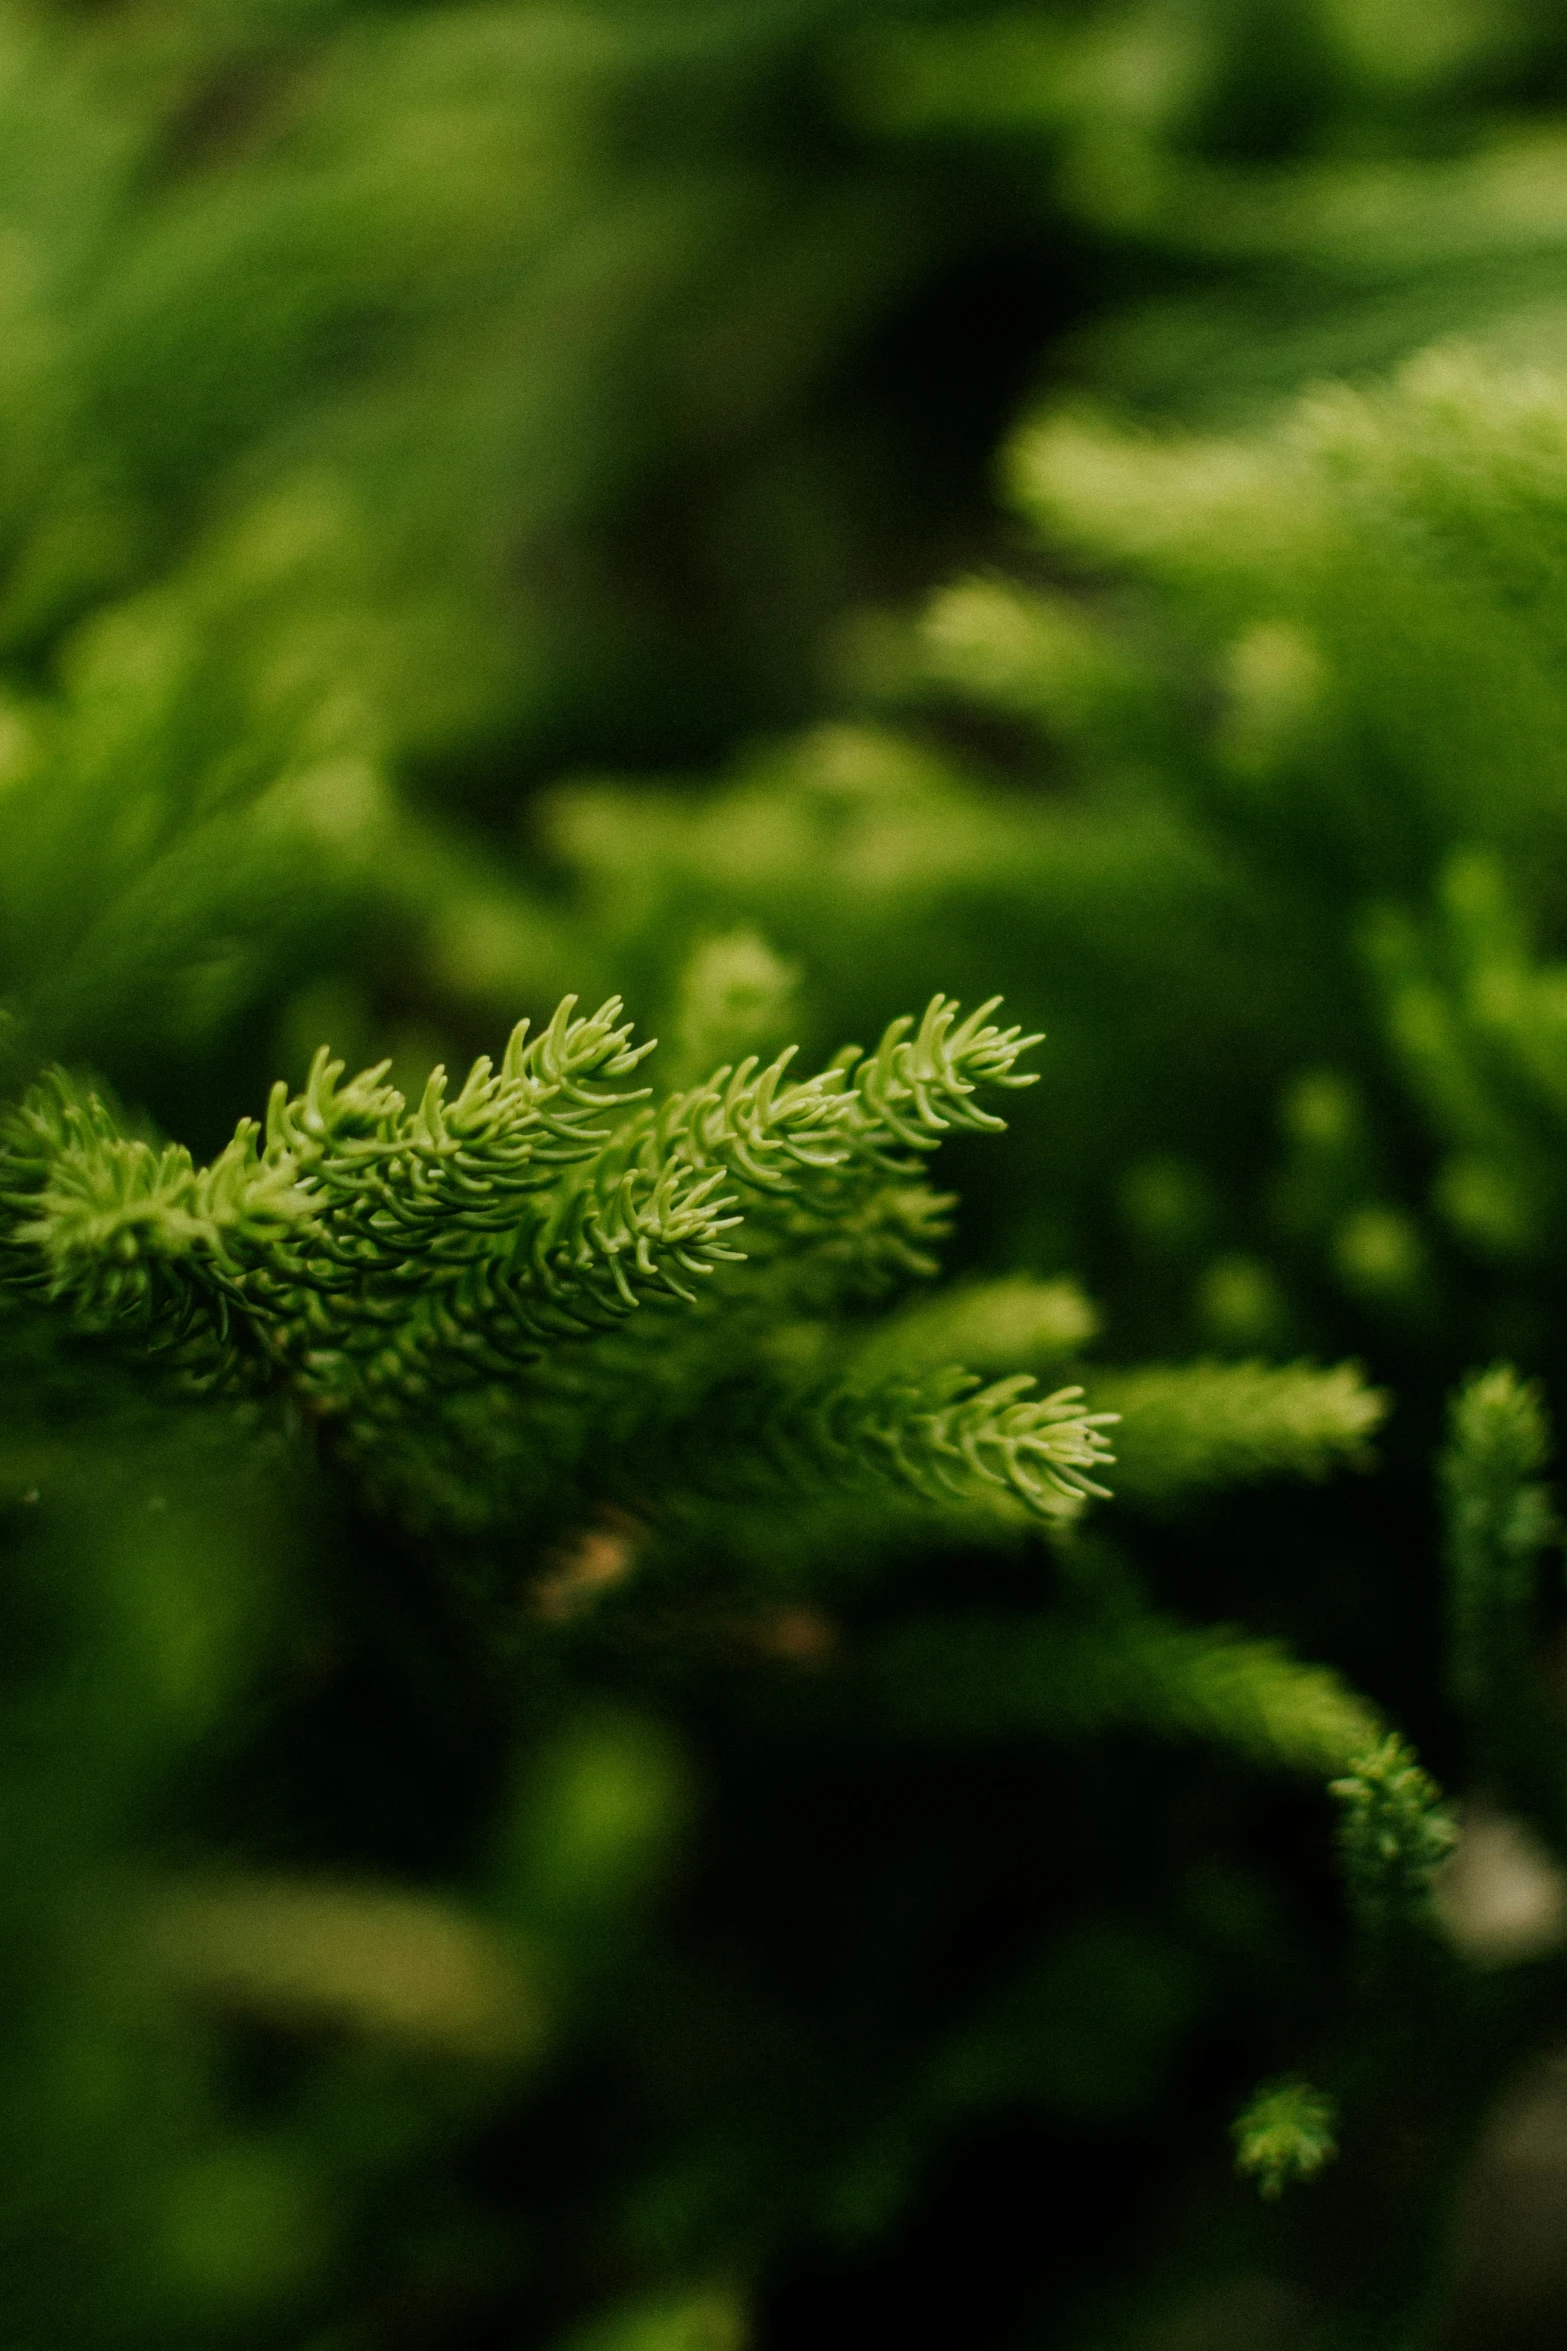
15 0 1567 2351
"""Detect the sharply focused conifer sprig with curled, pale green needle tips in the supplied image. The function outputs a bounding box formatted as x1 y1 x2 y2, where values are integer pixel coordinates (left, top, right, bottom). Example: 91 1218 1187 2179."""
0 997 1052 1514
